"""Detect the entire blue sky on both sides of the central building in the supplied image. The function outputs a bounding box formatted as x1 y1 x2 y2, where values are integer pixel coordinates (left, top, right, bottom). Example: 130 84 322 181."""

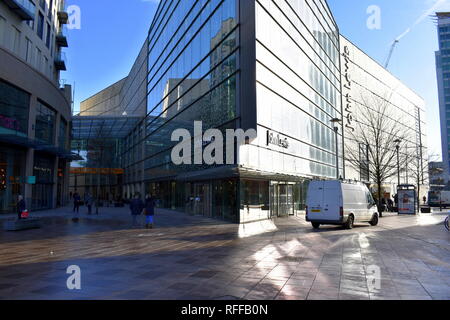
61 0 450 159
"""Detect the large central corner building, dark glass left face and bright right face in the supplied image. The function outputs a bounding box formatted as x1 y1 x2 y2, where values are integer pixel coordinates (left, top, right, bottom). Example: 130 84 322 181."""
115 0 342 223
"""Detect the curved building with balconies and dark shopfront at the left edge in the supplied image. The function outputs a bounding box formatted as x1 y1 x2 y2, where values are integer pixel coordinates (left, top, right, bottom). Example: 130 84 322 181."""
0 0 73 213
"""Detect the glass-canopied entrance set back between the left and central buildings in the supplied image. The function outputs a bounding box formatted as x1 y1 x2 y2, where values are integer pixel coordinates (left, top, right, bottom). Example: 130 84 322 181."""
69 116 141 206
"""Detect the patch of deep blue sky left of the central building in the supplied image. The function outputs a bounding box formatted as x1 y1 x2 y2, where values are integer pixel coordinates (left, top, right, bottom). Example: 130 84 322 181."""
61 0 158 110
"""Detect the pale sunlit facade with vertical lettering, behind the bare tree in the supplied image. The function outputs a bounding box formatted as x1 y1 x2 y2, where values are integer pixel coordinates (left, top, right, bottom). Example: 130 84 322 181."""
340 36 429 198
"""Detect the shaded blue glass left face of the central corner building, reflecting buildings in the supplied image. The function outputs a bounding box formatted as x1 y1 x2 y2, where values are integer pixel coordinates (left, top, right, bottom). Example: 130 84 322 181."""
143 0 238 179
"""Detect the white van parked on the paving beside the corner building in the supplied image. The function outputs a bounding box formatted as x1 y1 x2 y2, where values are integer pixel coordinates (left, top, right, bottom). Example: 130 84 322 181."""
306 180 378 229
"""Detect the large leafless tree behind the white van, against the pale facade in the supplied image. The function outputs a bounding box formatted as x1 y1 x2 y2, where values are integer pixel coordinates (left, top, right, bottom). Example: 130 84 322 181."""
345 96 409 215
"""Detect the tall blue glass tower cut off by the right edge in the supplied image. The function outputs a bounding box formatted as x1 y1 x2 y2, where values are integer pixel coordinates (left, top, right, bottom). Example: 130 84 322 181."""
436 12 450 183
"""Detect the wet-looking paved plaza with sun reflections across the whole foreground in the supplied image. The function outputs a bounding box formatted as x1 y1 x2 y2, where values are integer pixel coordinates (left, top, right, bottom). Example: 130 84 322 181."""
0 208 450 300
